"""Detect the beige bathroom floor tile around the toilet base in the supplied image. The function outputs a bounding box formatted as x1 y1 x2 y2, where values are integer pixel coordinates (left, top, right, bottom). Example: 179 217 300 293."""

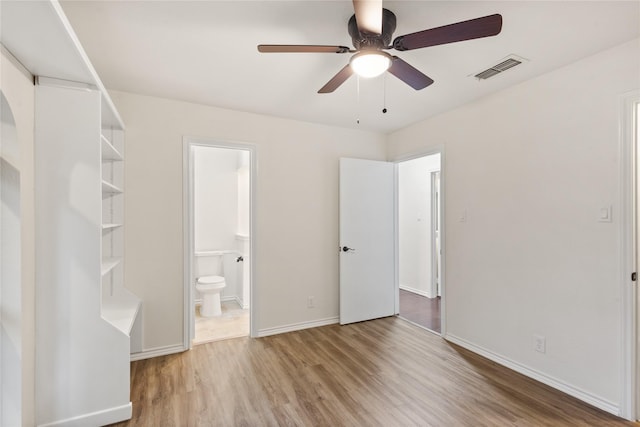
193 301 249 345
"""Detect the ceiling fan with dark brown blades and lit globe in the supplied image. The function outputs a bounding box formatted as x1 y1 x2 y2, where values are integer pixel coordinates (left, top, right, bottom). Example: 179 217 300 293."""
258 0 502 93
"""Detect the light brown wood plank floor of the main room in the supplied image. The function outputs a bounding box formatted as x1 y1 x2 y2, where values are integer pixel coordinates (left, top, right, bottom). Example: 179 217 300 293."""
116 317 638 427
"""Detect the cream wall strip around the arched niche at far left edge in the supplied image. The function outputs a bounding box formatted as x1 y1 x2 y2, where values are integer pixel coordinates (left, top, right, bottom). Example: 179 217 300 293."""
0 48 35 426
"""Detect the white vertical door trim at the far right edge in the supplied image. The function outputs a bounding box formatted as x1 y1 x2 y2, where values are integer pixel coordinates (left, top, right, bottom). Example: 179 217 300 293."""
618 90 640 420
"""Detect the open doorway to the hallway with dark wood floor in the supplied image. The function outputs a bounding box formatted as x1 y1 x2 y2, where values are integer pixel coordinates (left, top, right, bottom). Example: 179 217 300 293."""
397 152 442 334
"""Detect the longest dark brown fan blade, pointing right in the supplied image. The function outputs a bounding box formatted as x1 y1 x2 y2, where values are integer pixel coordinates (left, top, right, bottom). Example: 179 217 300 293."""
393 14 502 51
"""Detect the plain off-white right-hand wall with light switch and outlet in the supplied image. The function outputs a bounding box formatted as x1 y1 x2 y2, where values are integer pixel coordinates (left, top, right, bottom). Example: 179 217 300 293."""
388 40 640 409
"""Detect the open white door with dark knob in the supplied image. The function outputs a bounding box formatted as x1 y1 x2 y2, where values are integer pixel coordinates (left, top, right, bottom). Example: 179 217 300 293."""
340 158 397 325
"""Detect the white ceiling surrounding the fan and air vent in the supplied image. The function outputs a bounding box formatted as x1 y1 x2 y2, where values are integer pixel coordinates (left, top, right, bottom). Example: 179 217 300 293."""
61 0 640 133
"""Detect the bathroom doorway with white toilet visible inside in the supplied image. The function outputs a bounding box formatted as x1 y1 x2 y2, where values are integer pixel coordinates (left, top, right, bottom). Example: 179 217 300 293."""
184 138 255 348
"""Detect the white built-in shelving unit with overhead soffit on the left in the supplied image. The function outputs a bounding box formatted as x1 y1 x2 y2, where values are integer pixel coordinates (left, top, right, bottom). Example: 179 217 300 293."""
2 0 143 426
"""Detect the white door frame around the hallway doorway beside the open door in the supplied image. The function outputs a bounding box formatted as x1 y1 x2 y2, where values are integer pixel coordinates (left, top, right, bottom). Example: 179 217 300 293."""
392 145 447 337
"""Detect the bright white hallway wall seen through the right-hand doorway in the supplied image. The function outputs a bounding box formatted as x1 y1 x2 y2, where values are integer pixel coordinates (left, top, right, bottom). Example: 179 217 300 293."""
398 154 440 298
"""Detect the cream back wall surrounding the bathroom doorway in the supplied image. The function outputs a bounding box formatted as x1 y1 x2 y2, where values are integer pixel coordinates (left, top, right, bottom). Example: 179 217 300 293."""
112 92 386 350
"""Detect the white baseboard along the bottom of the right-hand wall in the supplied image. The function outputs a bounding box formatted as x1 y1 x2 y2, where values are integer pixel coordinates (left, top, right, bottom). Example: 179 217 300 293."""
444 334 620 416
